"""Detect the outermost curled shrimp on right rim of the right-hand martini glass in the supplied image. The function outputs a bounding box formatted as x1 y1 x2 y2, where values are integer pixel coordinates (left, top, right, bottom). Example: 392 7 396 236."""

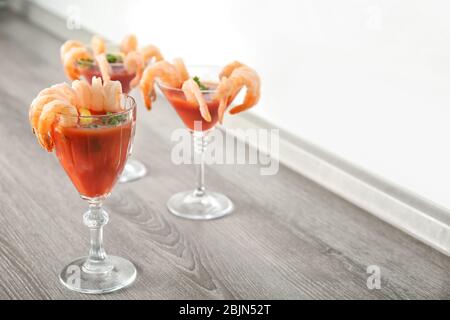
228 66 261 114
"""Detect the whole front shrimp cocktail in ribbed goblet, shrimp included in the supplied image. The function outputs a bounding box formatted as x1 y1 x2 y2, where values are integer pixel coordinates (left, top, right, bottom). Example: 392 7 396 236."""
29 77 136 293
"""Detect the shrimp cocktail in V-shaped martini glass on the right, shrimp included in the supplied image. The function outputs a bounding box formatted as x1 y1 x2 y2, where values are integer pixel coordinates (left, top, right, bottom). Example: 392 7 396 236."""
140 59 261 220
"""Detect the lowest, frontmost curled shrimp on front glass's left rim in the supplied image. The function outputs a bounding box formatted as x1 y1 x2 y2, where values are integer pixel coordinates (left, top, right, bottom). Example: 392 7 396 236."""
37 100 78 152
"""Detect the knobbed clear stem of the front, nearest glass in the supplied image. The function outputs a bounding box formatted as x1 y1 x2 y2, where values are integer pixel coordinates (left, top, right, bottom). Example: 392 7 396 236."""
83 199 113 273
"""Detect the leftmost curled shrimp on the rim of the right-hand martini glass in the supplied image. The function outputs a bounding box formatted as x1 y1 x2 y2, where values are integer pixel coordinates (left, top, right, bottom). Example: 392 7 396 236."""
139 60 182 110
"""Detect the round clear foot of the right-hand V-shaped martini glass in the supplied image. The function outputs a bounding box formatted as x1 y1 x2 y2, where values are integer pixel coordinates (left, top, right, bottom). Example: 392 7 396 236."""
167 191 234 220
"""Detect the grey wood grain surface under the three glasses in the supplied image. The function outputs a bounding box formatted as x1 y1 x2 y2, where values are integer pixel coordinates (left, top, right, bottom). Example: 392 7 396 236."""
0 11 450 299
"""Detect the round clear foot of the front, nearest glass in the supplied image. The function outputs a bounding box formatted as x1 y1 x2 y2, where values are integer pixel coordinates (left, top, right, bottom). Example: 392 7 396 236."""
59 256 136 294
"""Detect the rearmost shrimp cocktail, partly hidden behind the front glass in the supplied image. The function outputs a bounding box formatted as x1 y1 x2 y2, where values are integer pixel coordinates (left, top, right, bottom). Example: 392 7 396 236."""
60 35 163 182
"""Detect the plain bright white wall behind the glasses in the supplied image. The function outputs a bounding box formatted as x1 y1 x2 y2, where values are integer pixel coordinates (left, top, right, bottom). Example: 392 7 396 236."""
30 0 450 208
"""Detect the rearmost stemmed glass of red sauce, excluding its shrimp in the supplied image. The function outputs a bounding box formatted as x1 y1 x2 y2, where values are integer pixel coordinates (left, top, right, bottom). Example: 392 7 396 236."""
78 62 147 182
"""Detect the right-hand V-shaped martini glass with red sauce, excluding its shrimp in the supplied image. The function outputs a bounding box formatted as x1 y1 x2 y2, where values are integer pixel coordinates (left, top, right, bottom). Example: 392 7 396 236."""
157 66 234 220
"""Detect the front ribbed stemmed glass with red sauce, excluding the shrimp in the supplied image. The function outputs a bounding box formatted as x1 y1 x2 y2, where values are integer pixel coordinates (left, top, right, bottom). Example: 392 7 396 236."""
52 94 136 293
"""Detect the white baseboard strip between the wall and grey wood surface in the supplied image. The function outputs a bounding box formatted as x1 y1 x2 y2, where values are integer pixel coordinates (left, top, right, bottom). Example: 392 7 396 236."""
10 0 450 256
